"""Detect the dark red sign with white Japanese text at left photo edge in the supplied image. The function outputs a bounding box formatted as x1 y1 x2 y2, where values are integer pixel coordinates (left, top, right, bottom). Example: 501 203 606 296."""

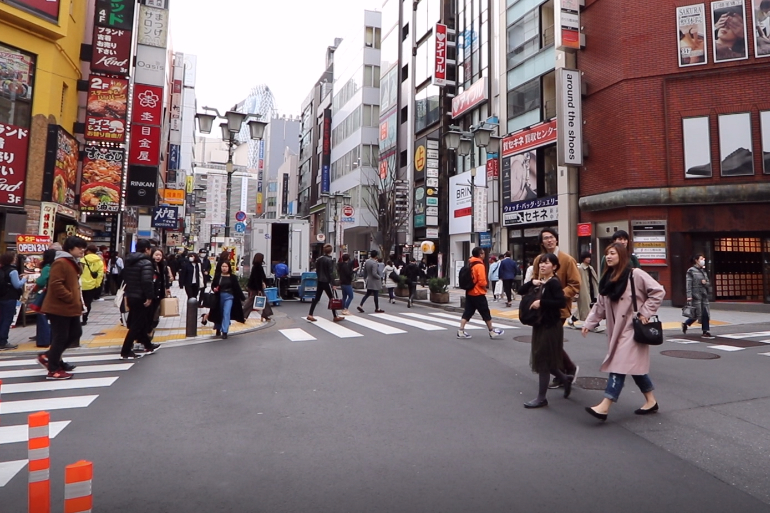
0 123 29 206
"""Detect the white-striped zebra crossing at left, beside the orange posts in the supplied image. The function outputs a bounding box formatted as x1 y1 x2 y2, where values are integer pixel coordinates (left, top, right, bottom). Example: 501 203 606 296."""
0 354 134 488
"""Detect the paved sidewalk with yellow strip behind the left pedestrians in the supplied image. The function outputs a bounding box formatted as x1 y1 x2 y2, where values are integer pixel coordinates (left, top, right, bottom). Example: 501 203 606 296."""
0 285 273 357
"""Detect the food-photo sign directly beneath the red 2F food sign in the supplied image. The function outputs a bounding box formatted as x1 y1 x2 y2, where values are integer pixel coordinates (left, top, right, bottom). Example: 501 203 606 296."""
80 146 125 212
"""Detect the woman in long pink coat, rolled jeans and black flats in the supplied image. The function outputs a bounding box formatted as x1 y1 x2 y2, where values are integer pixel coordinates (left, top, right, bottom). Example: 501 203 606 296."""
583 243 665 420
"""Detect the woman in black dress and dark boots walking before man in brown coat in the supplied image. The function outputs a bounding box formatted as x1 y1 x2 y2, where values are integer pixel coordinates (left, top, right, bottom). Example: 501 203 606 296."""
521 253 574 408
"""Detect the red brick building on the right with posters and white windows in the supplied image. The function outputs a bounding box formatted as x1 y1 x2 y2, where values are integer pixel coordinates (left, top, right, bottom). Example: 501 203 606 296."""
578 0 770 304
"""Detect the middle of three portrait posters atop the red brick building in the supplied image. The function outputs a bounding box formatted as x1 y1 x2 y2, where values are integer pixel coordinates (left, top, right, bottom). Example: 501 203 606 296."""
711 0 749 62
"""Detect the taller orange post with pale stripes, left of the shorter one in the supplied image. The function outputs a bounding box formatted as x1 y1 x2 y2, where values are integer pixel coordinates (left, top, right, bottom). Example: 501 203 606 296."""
28 411 51 513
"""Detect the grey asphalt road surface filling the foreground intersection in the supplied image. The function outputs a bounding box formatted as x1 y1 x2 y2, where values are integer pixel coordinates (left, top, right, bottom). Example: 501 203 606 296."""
0 303 770 513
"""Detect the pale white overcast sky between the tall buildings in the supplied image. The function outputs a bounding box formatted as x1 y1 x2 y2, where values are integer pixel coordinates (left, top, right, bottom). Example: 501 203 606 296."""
170 0 382 115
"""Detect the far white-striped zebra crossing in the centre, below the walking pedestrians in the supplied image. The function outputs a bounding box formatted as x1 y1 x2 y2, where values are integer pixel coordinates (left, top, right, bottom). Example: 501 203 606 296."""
279 312 520 342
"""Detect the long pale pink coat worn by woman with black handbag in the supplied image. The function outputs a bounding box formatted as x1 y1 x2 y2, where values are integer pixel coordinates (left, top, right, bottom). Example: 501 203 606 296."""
584 269 666 376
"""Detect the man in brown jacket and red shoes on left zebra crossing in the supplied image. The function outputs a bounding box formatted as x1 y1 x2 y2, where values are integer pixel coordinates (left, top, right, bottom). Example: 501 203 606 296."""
37 237 88 380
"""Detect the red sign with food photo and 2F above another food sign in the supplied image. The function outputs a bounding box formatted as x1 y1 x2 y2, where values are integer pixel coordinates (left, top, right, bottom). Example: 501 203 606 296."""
85 75 128 142
